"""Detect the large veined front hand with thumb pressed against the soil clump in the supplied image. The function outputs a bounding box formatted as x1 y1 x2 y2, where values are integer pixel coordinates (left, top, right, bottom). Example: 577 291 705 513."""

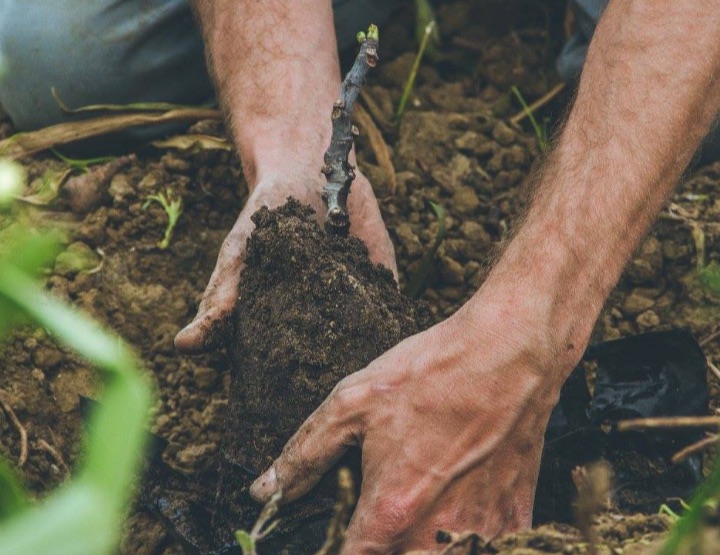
250 297 574 555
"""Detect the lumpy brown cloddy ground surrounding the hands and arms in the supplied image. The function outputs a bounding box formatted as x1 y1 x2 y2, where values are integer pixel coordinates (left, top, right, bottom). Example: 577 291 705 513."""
0 0 720 555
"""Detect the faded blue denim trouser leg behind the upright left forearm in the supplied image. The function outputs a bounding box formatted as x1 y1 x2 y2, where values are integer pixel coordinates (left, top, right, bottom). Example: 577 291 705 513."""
0 0 396 130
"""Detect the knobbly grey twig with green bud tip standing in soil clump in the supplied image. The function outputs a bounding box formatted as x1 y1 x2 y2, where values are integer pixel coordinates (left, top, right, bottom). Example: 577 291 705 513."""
322 25 379 237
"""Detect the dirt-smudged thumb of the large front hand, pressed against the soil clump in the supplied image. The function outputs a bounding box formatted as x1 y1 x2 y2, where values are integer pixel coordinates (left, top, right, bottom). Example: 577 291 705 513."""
250 382 363 502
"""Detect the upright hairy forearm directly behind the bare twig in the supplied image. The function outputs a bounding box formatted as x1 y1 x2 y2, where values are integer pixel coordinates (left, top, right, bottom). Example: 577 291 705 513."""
193 0 340 188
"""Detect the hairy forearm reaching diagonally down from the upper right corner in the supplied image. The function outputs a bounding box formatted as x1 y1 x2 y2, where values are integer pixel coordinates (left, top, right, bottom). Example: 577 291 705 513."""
466 0 720 378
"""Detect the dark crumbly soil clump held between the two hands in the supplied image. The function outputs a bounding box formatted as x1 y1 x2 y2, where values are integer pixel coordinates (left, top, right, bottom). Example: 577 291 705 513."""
213 199 433 552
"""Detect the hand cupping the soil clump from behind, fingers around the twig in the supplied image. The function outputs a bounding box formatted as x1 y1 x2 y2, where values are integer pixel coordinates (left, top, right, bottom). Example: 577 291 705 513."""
175 172 397 354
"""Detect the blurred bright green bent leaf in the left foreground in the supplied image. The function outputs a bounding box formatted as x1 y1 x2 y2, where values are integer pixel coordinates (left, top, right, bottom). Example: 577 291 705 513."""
0 167 152 555
